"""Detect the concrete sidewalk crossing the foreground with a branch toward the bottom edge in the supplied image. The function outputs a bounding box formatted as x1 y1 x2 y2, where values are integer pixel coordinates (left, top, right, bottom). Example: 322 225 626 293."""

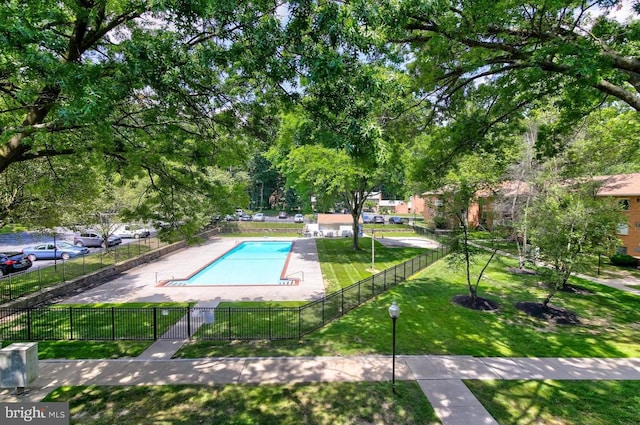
0 355 640 425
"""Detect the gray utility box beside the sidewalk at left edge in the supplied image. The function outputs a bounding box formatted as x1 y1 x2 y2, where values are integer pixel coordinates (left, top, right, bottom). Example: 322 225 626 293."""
0 342 38 388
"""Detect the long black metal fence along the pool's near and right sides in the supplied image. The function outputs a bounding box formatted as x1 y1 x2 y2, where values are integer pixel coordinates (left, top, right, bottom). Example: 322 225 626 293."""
0 248 446 341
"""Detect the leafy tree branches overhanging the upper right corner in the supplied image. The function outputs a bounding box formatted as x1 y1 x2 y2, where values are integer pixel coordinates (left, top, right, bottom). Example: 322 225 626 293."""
378 0 640 113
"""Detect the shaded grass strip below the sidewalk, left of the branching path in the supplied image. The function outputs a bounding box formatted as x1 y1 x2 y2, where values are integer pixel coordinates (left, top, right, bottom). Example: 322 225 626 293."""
44 382 441 425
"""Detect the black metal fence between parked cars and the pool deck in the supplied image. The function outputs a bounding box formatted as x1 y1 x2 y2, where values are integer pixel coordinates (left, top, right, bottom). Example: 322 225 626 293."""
0 238 167 303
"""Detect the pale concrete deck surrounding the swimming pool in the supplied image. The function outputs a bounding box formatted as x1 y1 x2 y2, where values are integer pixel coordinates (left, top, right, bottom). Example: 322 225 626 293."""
61 237 325 307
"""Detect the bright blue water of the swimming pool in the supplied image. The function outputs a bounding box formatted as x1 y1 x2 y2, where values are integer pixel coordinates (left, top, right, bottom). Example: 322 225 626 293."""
164 241 293 286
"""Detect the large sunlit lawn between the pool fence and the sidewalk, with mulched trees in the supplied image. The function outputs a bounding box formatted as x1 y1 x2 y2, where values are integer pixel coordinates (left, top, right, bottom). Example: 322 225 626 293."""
177 252 640 358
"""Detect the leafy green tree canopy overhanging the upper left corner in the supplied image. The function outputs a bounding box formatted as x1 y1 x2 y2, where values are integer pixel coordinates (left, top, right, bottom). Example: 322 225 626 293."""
0 0 292 232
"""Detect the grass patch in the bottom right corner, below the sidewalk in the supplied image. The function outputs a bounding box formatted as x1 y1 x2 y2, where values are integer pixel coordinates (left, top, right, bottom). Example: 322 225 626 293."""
465 380 640 425
